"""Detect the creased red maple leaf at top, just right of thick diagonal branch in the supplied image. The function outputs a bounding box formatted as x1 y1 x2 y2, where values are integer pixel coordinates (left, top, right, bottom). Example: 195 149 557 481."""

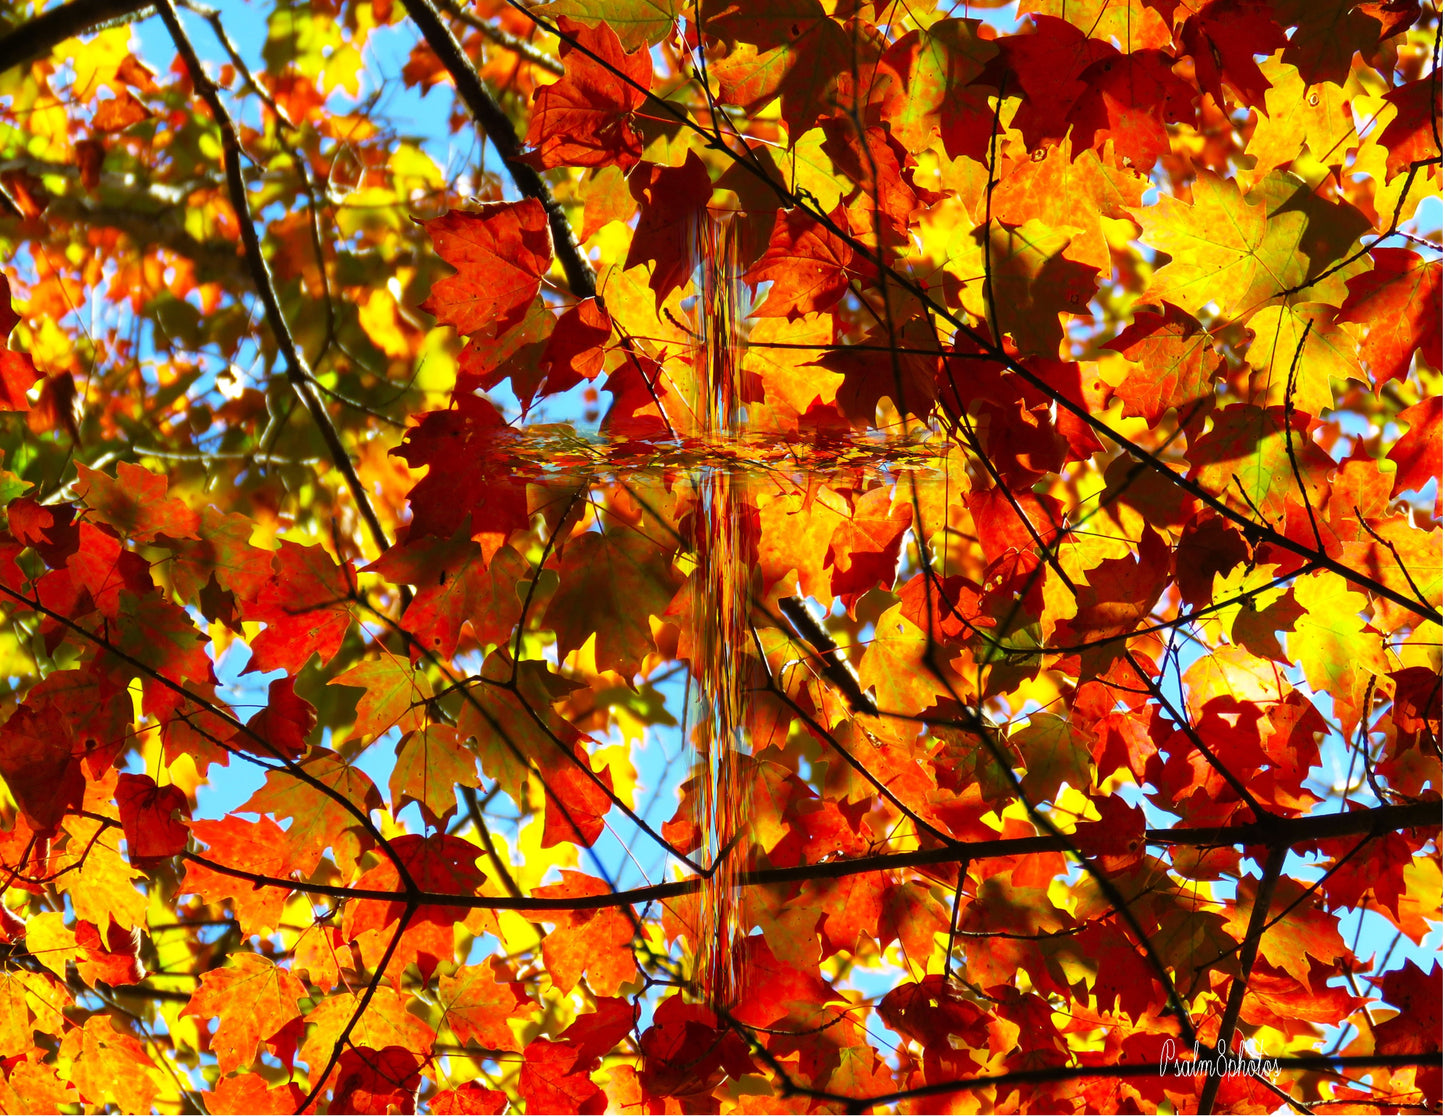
525 16 652 169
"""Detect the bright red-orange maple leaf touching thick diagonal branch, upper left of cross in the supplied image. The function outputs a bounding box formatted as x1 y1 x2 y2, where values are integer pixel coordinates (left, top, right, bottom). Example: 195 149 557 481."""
422 200 554 337
